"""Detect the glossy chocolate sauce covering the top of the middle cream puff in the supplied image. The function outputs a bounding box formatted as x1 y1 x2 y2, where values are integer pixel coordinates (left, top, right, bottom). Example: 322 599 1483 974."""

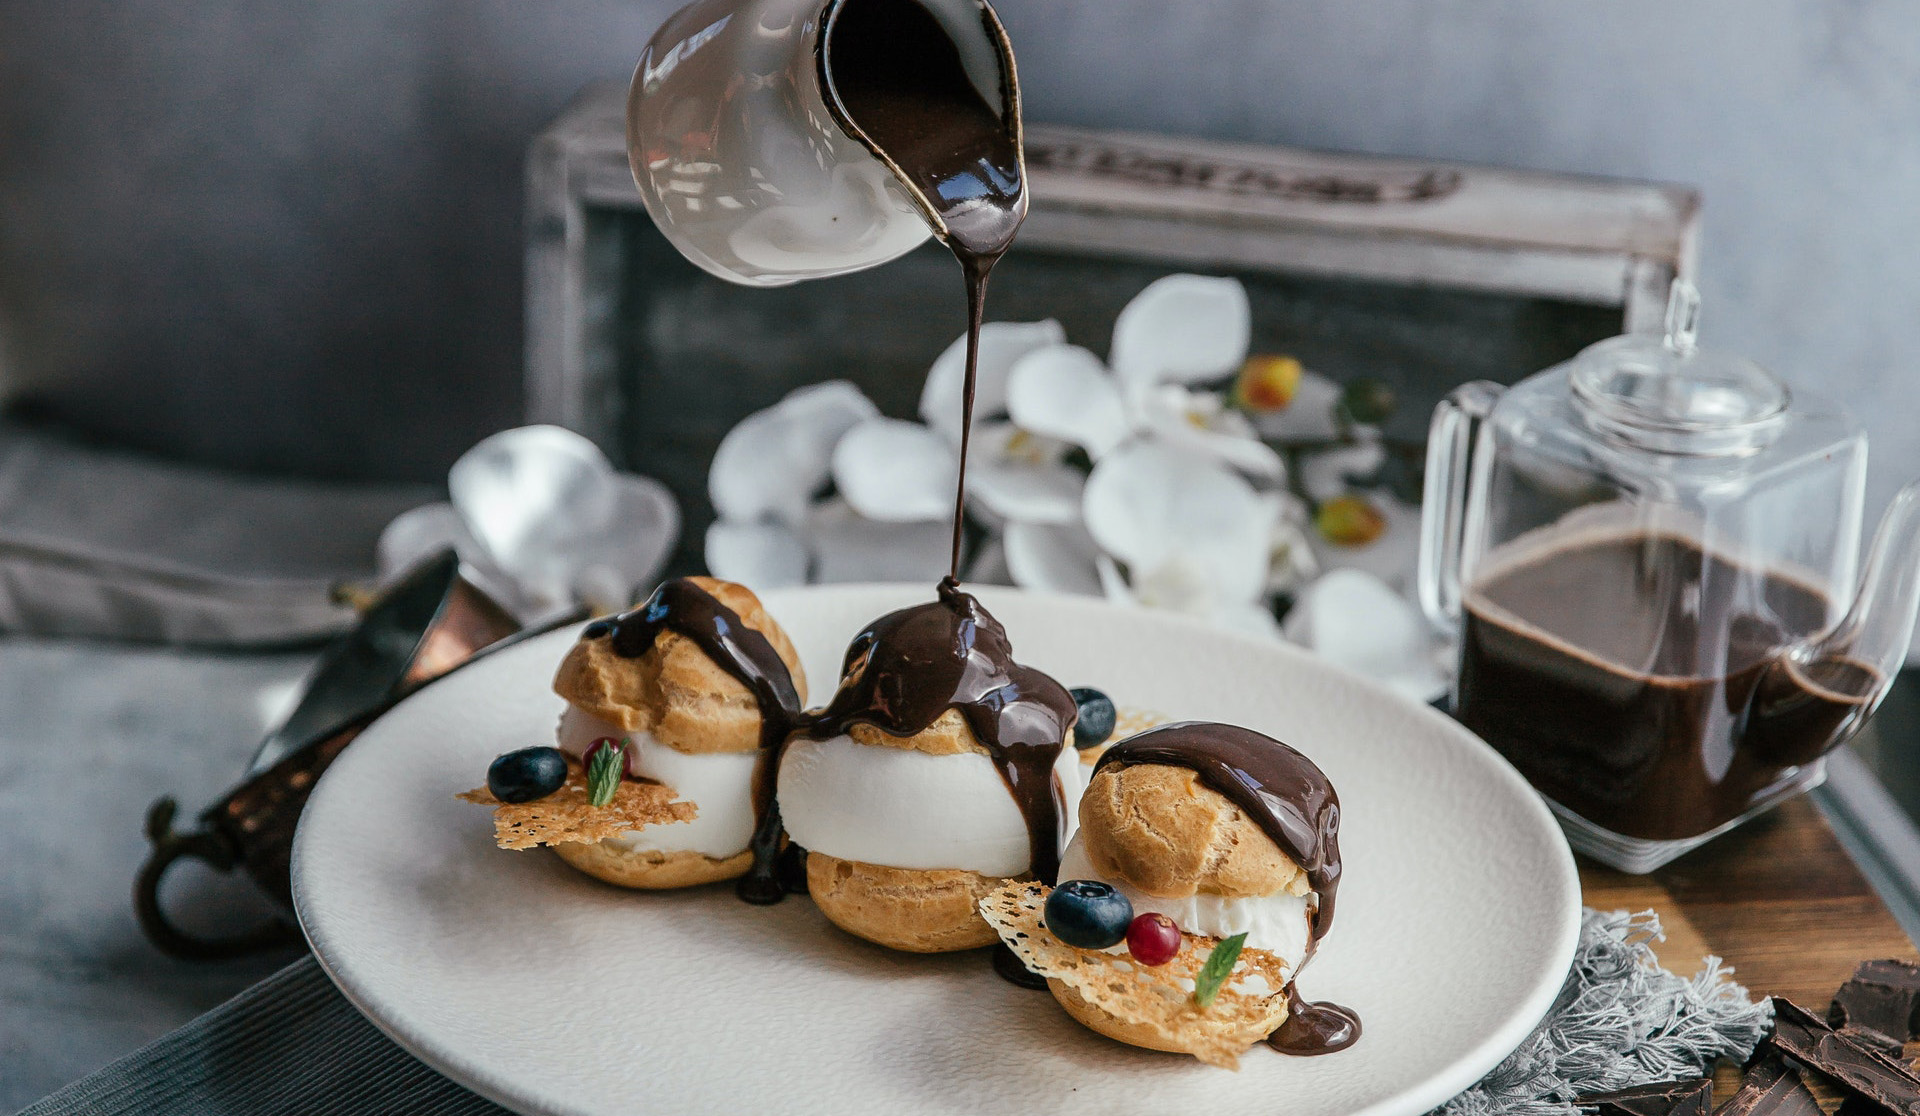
803 578 1077 884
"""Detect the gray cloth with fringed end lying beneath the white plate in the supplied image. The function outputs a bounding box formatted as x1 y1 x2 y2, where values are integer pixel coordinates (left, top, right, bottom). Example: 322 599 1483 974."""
21 910 1770 1116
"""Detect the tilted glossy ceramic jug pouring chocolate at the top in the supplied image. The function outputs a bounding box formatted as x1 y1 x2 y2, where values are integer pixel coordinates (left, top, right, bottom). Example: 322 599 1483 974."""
626 0 1020 286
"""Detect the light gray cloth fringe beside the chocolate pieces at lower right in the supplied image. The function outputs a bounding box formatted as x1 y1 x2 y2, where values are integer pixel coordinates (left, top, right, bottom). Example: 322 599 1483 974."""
1434 910 1772 1116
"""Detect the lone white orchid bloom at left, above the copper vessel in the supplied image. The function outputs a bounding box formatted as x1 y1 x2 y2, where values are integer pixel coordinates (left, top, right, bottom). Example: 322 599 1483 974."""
378 426 680 622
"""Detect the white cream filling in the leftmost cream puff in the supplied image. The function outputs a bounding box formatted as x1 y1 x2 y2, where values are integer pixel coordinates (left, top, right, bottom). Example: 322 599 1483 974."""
559 705 760 861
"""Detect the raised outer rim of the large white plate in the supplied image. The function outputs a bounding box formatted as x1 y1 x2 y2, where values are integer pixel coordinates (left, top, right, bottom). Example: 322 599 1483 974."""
292 584 1580 1116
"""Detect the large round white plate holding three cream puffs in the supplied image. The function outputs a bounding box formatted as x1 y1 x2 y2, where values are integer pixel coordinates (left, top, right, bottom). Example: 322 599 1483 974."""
294 586 1580 1116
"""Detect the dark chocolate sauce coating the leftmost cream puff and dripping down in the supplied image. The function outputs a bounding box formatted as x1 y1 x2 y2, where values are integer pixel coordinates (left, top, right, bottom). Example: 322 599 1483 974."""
580 578 804 903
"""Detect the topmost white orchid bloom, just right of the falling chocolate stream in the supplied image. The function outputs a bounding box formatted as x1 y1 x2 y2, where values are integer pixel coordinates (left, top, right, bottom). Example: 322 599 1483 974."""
1006 275 1284 480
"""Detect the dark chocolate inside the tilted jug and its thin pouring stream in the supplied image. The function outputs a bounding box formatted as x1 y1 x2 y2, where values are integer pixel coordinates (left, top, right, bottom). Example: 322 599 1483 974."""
822 0 1027 578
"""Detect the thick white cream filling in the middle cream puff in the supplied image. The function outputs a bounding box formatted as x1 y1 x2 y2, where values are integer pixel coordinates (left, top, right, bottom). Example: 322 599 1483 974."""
780 736 1085 876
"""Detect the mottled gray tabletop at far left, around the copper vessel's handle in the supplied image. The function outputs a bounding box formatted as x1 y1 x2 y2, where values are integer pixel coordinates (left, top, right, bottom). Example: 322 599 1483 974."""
0 638 313 1112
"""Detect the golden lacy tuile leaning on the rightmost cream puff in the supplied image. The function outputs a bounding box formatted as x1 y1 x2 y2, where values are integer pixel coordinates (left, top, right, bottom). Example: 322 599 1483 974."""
979 882 1288 1070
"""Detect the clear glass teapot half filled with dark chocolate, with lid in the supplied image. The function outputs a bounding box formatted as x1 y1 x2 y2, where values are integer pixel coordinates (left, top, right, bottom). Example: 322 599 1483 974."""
1419 282 1920 872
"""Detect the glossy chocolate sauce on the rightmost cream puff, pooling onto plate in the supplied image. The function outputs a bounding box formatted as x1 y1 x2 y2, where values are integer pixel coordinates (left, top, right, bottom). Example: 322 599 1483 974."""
1092 720 1359 1055
